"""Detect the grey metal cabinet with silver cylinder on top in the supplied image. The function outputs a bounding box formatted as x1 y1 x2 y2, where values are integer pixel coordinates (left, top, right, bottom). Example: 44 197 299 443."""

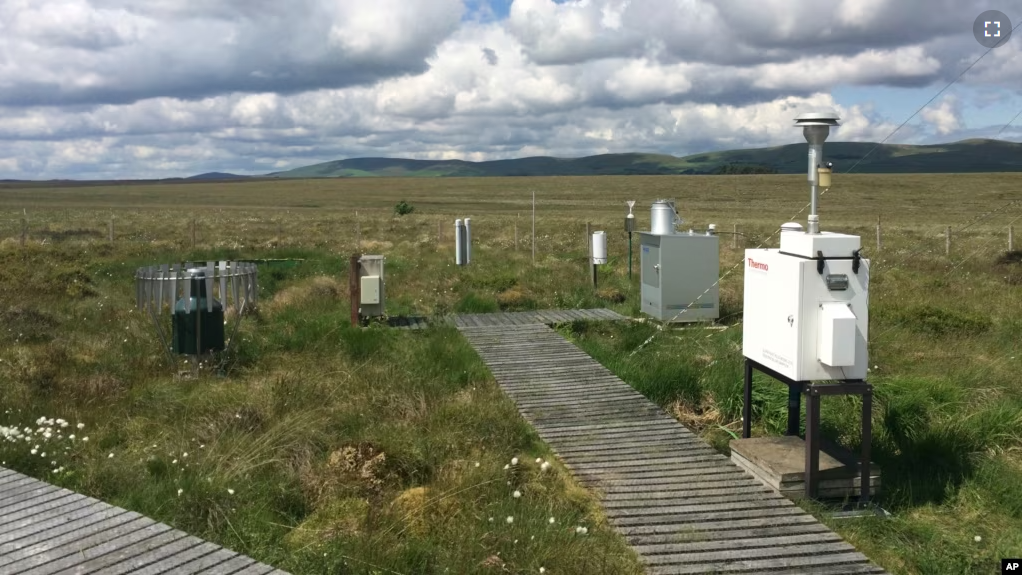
639 200 721 324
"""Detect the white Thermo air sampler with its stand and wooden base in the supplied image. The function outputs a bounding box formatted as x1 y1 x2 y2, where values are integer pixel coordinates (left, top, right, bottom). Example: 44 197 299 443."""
732 112 879 503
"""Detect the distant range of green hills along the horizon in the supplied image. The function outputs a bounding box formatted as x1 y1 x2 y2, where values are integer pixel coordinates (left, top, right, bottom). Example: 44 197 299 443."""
267 140 1022 178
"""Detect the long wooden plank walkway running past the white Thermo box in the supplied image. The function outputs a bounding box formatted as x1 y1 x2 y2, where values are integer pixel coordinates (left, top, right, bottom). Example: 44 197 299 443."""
460 324 883 574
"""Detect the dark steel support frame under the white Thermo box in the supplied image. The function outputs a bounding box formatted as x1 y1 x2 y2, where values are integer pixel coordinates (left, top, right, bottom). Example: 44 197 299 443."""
742 358 873 506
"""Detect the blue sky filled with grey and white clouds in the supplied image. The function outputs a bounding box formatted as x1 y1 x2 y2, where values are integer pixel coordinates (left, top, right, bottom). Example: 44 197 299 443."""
0 0 1022 179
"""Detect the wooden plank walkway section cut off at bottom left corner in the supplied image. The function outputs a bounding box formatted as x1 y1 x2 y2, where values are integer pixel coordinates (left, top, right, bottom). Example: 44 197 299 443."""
0 468 287 574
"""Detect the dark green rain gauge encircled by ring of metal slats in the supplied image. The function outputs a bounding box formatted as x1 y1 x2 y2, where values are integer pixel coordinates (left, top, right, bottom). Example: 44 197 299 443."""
135 260 259 368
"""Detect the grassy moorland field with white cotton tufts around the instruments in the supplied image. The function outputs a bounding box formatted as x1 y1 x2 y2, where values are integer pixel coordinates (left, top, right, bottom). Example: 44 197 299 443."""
0 175 1022 573
